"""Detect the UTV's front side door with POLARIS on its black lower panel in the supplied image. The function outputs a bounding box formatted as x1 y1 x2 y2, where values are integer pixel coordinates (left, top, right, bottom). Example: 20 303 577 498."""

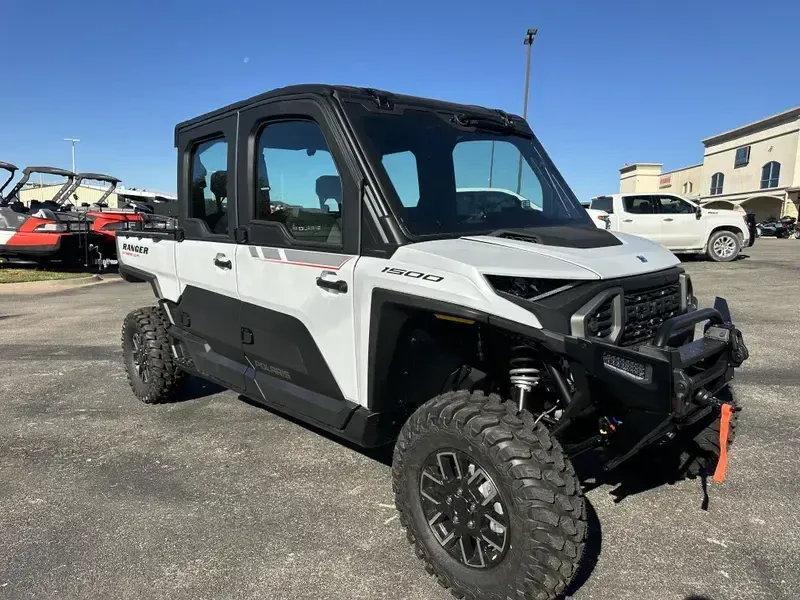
237 97 360 428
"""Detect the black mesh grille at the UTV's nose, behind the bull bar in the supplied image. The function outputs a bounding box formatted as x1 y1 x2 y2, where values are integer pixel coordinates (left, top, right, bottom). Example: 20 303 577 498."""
620 282 681 346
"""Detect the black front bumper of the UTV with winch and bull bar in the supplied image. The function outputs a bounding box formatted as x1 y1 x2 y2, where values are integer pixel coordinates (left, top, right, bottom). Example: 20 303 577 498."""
563 299 747 423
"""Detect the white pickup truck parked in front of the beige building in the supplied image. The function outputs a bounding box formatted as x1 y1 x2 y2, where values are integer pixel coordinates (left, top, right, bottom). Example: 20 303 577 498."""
590 194 753 262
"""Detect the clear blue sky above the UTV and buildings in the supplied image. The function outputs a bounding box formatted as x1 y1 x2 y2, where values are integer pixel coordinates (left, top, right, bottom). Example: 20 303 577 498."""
0 0 800 199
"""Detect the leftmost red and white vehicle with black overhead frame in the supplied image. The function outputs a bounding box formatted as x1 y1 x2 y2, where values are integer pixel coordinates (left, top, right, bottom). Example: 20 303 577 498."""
0 163 98 265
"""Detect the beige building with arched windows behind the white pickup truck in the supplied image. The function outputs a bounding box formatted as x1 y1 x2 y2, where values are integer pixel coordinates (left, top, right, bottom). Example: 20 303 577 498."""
619 107 800 220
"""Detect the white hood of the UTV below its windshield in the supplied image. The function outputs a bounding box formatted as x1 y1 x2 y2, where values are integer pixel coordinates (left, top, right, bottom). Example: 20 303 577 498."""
395 232 680 279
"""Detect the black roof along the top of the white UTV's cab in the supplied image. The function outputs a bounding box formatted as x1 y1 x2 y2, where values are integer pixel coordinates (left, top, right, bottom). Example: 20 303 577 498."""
175 83 522 140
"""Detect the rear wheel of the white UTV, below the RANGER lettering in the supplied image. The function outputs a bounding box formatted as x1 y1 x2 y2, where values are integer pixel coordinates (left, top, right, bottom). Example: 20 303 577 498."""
122 306 183 404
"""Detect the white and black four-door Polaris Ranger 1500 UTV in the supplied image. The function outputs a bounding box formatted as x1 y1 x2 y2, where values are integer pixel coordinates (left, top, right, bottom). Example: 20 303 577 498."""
117 85 747 600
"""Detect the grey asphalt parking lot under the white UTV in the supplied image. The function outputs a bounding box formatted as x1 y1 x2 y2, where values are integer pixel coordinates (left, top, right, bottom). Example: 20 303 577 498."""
0 240 800 600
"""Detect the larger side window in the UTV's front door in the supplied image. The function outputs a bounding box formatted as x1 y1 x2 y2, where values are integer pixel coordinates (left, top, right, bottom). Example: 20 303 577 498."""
255 121 344 246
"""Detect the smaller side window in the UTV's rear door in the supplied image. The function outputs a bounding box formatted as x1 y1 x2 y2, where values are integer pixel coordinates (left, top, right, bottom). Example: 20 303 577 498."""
189 138 228 234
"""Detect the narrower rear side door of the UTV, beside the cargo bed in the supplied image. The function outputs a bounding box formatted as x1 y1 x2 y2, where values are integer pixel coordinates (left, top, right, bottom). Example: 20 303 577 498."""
173 114 245 389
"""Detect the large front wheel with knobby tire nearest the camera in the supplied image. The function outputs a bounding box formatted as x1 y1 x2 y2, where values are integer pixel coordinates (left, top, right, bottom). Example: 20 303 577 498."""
392 391 587 600
